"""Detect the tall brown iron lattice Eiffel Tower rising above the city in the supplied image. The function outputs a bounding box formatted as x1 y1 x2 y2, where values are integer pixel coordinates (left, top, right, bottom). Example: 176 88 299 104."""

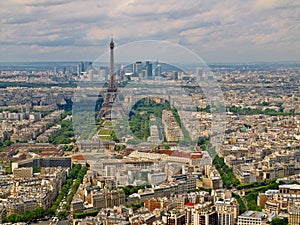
98 37 125 120
